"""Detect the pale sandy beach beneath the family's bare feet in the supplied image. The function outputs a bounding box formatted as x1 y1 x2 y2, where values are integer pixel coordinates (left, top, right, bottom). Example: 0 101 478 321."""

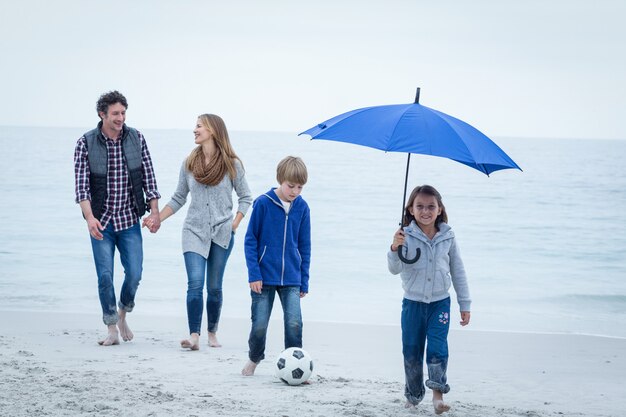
0 311 626 417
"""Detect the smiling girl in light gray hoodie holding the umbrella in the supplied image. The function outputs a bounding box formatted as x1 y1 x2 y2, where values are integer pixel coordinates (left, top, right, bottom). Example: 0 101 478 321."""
387 185 471 414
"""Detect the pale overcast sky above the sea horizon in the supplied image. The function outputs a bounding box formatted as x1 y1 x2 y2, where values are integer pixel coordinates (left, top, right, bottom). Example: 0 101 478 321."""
0 0 626 139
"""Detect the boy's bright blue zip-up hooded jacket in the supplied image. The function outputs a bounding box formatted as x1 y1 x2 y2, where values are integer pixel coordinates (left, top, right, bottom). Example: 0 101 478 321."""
244 188 311 293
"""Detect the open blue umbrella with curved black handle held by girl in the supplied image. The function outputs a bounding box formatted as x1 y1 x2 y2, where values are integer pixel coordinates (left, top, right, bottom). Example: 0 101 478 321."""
300 88 521 263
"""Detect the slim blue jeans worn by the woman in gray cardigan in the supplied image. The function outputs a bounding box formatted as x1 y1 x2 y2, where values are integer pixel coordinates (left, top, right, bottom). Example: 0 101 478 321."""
183 234 235 334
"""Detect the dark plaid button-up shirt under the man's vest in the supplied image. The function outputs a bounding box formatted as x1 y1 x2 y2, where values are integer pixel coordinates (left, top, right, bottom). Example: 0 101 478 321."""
74 127 161 232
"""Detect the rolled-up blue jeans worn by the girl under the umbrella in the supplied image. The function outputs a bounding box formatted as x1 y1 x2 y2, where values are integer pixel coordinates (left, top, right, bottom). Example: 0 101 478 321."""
401 297 450 404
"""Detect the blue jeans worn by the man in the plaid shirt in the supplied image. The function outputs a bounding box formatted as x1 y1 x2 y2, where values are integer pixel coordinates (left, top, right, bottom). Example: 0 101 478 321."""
91 222 143 326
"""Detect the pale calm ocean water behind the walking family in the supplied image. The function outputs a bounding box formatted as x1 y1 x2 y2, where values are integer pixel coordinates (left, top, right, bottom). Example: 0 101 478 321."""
0 123 626 338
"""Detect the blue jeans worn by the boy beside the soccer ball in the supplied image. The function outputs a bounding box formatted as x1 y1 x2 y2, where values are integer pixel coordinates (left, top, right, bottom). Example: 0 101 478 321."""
248 285 302 363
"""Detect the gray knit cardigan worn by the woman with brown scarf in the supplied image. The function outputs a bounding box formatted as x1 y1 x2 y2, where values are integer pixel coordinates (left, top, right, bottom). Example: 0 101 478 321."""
167 158 252 258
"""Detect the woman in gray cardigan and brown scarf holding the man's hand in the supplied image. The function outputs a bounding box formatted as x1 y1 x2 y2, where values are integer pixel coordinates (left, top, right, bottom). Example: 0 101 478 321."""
144 114 252 350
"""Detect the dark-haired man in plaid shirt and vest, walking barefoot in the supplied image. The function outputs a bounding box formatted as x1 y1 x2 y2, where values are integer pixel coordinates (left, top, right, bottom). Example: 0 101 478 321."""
74 91 161 346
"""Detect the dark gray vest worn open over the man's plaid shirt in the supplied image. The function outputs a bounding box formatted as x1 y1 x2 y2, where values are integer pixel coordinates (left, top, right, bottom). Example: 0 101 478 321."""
85 122 147 220
